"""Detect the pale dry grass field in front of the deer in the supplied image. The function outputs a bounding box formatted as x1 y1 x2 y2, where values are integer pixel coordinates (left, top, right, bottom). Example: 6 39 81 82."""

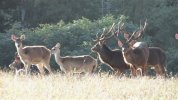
0 72 178 100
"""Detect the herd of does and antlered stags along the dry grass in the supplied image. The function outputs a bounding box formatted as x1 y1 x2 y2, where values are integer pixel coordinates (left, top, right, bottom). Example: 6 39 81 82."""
9 20 166 77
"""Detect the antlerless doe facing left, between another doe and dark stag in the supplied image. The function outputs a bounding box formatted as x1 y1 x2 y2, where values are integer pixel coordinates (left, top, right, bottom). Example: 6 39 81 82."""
51 43 97 74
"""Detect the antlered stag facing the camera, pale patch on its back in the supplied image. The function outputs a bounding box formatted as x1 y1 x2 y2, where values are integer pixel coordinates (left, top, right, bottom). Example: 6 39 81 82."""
116 21 149 76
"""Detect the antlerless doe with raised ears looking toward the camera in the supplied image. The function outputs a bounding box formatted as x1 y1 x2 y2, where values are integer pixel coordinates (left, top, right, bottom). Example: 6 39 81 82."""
11 35 52 75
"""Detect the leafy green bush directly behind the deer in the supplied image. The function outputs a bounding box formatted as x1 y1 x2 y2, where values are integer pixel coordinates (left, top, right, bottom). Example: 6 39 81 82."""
0 15 178 73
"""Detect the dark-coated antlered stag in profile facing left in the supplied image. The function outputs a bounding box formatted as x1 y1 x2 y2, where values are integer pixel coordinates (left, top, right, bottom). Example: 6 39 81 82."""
91 24 130 75
